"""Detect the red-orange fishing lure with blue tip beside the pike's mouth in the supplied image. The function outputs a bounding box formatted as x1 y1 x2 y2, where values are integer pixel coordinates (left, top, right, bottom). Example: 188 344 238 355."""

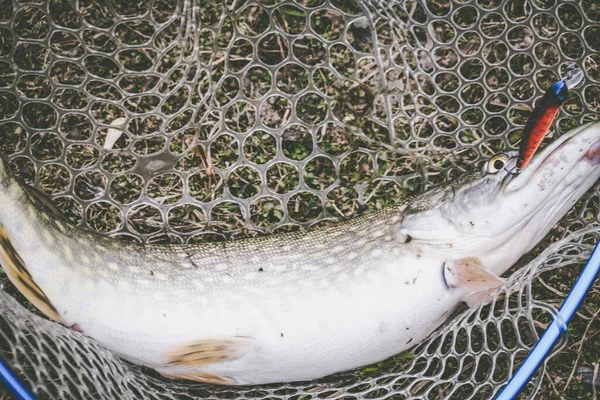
517 66 583 171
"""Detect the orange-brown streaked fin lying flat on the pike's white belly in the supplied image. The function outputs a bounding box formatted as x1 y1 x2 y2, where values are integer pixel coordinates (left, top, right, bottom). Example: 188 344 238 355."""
167 336 254 368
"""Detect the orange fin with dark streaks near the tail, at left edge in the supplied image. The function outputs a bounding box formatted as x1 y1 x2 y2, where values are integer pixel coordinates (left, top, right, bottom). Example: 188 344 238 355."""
0 224 60 322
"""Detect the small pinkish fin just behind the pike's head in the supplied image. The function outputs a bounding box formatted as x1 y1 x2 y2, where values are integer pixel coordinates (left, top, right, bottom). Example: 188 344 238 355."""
443 257 504 307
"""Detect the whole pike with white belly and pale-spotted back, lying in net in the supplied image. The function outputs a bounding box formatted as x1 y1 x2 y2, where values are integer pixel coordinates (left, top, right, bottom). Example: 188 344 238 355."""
0 123 600 385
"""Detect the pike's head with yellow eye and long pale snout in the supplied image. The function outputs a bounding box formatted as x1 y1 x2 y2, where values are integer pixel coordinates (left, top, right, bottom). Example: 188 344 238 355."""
397 123 600 273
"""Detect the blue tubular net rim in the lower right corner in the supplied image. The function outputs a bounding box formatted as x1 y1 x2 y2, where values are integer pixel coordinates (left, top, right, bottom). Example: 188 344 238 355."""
496 241 600 400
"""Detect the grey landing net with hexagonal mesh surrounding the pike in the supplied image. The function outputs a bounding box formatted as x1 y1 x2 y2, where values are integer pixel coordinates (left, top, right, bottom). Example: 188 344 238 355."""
0 0 600 399
